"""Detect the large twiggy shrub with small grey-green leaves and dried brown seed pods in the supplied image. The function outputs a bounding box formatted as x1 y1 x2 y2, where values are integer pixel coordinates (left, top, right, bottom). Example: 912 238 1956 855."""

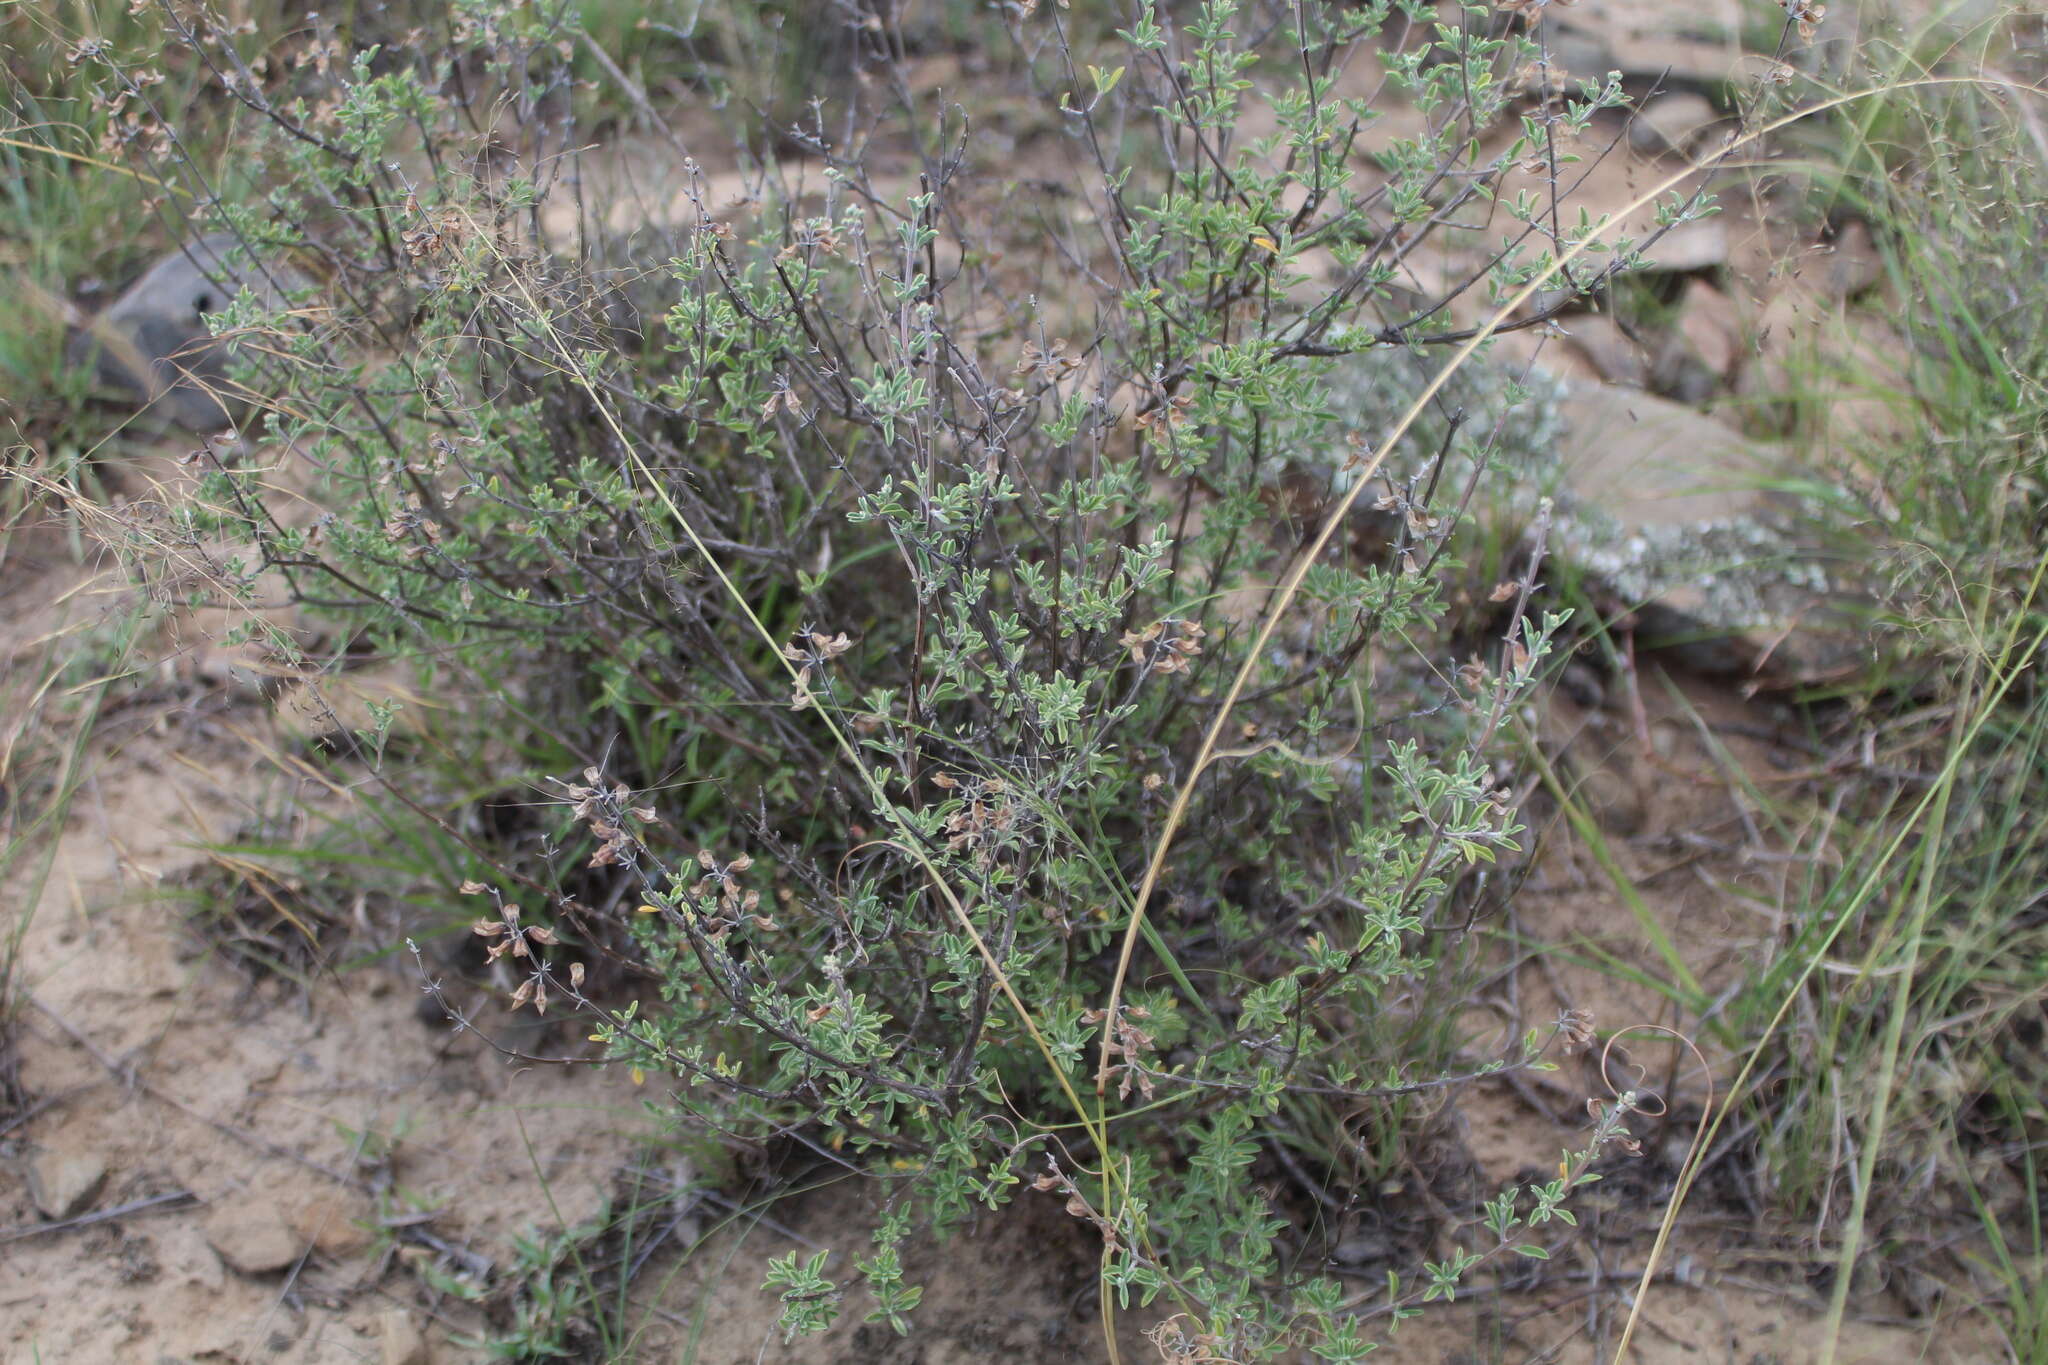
59 0 1706 1361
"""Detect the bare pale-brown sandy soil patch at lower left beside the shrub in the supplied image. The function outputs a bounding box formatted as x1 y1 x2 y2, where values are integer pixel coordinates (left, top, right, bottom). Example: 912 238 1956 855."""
0 493 645 1363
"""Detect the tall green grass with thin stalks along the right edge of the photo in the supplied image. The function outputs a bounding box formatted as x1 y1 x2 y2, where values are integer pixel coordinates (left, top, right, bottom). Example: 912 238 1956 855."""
1548 16 2048 1359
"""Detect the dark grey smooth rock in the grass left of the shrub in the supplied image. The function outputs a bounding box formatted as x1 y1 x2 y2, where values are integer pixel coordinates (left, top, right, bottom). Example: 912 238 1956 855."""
70 233 305 432
